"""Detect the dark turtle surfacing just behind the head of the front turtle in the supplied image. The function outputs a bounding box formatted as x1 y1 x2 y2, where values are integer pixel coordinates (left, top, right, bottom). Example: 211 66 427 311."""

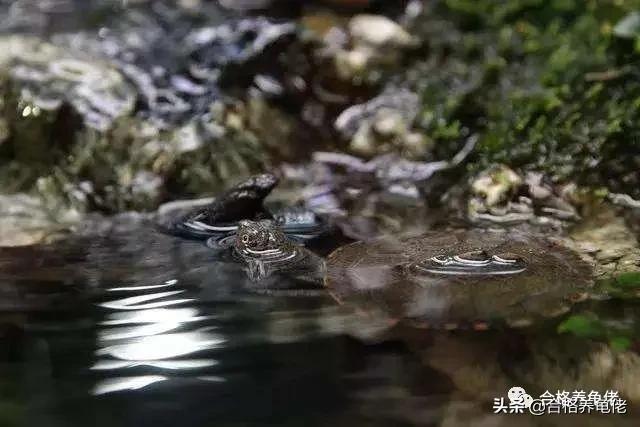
159 173 329 250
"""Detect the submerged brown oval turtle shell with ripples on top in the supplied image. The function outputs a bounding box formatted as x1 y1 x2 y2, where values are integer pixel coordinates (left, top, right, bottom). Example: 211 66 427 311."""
325 230 593 328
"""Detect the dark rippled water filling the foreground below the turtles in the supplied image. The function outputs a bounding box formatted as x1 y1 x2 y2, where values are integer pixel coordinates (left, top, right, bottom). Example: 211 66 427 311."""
0 217 640 426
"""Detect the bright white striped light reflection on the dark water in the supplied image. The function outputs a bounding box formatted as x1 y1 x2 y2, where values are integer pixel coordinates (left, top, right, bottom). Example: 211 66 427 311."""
91 280 225 394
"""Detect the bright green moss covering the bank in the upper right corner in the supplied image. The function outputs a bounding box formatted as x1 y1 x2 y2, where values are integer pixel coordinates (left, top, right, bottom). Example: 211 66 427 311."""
402 0 640 196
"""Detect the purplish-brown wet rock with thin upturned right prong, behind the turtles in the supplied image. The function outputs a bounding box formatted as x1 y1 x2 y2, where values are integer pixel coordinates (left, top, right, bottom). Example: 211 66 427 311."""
277 137 477 240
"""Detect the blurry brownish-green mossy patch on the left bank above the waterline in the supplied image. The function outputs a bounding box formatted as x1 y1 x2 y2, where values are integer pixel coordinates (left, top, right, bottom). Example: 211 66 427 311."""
38 118 268 213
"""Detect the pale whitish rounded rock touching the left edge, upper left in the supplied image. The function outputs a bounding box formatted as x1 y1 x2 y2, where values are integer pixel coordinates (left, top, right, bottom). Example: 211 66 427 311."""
0 36 135 133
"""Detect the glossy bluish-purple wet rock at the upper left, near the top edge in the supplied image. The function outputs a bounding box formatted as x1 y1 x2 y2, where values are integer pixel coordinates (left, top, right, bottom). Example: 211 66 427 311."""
56 5 296 127
